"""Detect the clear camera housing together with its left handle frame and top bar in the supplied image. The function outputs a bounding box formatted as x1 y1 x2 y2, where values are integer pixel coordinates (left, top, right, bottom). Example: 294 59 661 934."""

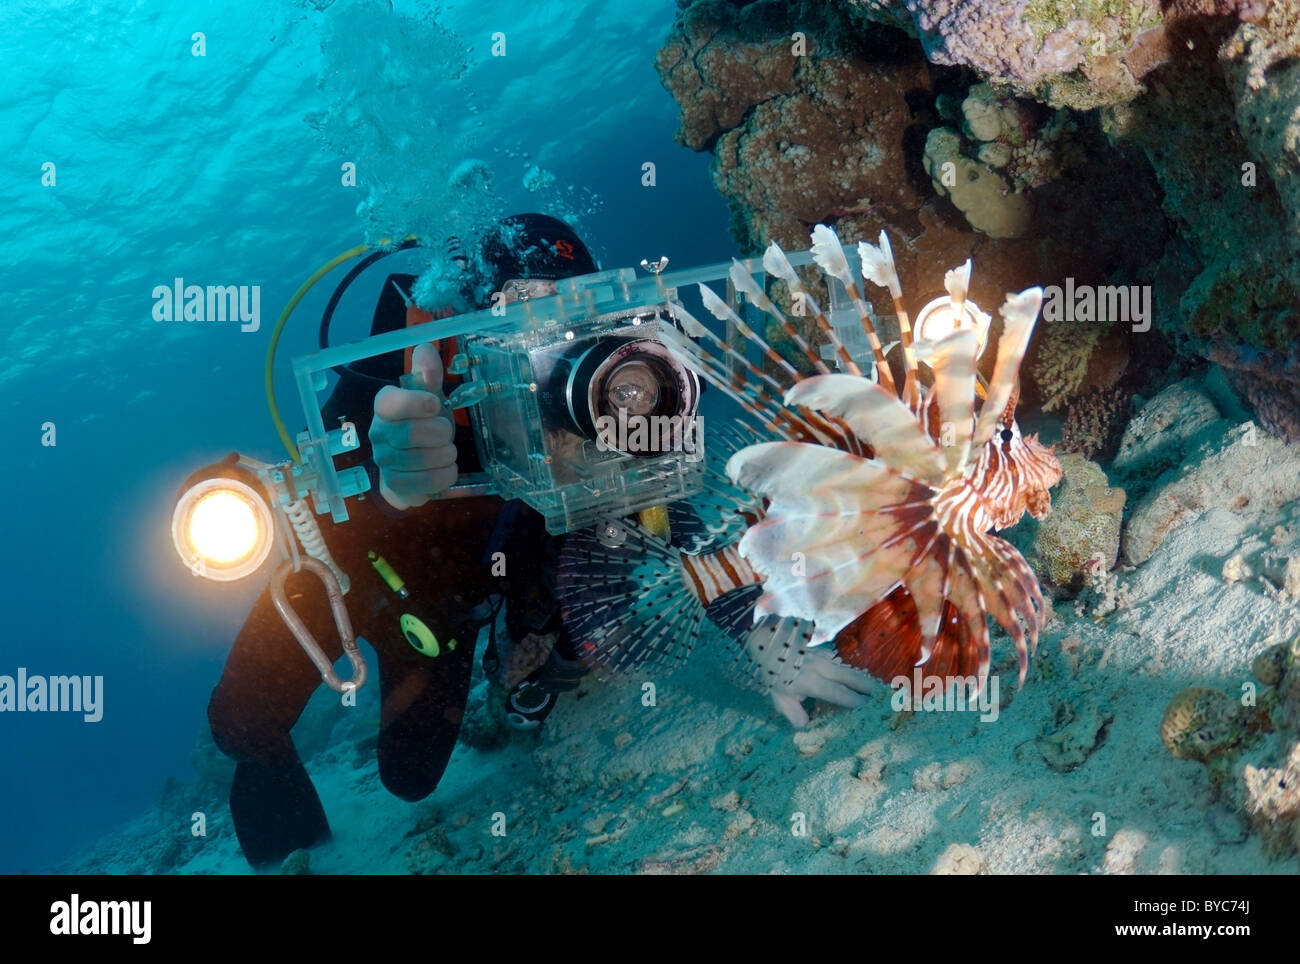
294 268 714 533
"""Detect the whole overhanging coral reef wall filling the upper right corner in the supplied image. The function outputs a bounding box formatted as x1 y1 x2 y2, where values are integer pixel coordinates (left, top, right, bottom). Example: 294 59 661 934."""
659 0 1300 431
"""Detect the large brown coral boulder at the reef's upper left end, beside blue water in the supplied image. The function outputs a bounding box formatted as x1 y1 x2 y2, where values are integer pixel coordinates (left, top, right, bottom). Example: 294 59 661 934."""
657 3 930 248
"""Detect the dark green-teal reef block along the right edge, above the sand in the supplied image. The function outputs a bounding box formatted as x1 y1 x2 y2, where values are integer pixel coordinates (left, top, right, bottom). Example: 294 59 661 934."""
1104 0 1300 440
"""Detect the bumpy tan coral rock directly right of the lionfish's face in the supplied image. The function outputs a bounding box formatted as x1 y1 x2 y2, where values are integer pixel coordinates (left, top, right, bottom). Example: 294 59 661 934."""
1027 453 1126 594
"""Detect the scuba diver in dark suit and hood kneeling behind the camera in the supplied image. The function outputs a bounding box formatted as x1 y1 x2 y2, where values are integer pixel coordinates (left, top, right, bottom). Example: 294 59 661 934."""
208 214 598 868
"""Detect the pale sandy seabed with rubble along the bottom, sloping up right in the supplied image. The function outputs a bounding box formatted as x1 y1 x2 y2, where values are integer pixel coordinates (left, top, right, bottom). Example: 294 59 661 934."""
61 376 1300 873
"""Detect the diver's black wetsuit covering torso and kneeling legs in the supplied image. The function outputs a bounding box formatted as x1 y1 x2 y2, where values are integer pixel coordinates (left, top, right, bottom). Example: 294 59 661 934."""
208 275 559 867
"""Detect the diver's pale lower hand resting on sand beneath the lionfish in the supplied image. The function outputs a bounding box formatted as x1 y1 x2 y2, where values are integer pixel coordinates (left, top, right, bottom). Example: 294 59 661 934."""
745 617 872 729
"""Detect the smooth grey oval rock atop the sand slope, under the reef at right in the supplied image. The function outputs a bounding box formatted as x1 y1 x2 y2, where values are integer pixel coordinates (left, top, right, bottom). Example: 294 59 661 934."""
1112 381 1227 478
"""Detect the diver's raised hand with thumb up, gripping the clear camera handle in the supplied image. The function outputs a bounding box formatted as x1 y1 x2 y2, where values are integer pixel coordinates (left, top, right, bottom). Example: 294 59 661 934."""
369 344 456 509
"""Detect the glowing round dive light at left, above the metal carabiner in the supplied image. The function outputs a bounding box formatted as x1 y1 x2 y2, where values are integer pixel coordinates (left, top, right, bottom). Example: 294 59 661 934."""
172 464 276 582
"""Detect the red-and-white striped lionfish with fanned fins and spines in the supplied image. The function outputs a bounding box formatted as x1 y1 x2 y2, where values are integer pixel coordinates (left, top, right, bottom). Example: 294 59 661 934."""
560 225 1061 691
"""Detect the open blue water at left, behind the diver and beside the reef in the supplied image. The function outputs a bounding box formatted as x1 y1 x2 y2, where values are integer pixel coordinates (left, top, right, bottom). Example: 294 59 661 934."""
0 0 735 872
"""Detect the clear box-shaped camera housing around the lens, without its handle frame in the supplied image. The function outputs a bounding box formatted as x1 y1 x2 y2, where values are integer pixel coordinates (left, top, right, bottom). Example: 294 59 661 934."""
443 300 703 531
